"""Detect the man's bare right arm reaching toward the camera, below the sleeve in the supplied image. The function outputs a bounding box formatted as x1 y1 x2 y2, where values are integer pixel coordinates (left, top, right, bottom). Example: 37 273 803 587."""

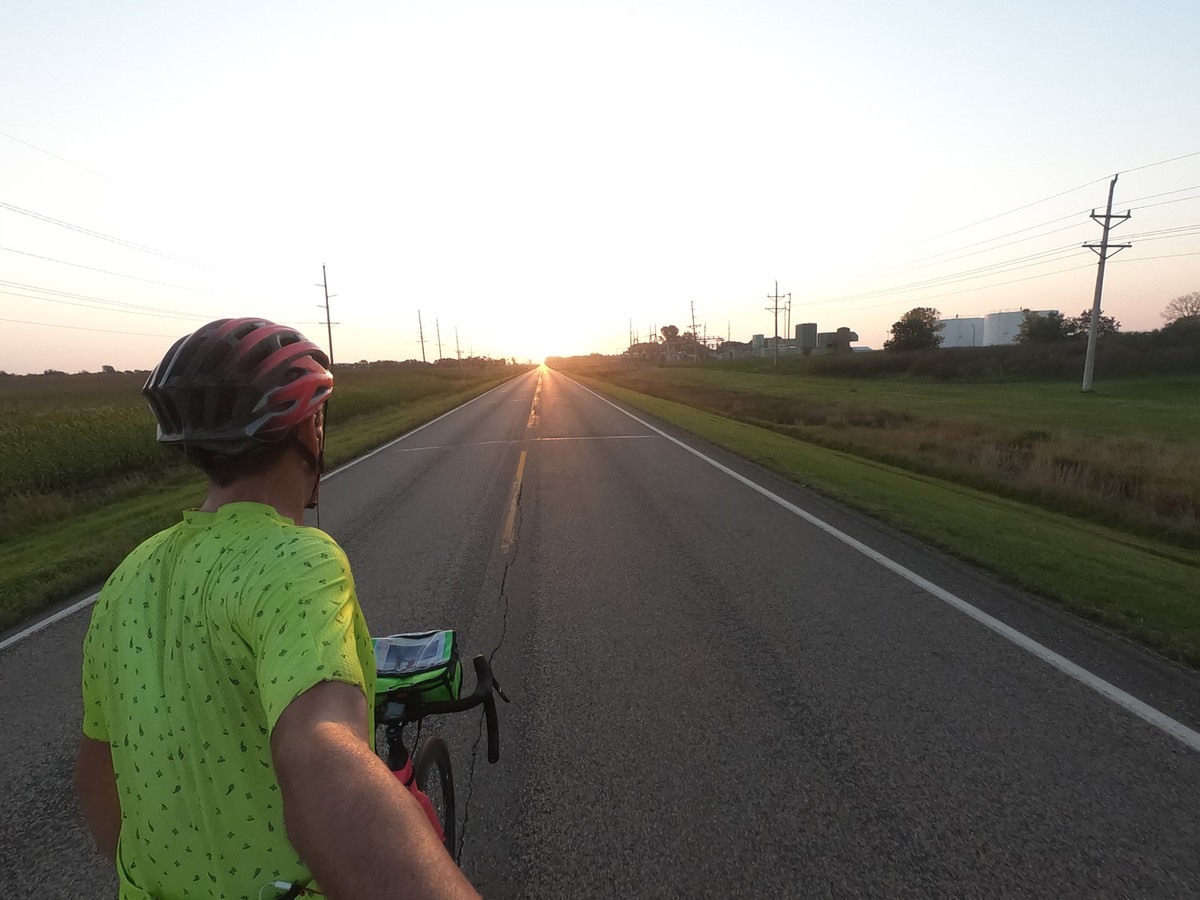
271 682 479 898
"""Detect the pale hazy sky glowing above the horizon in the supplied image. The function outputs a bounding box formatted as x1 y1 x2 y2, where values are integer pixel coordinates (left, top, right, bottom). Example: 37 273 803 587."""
0 0 1200 372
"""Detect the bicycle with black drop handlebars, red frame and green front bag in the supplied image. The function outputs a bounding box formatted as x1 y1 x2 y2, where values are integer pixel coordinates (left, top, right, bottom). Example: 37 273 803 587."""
374 631 509 859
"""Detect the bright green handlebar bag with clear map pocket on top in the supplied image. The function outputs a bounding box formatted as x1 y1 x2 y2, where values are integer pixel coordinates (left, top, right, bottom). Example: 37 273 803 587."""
373 631 462 703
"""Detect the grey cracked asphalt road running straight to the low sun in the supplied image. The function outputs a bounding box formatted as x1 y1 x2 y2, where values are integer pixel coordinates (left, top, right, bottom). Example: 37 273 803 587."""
0 370 1200 898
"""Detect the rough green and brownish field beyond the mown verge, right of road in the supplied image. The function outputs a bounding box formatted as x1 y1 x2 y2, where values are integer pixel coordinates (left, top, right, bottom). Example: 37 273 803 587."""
576 366 1200 548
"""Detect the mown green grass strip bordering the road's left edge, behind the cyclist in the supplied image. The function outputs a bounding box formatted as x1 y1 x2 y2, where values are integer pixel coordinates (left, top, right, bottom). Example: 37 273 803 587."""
0 373 512 632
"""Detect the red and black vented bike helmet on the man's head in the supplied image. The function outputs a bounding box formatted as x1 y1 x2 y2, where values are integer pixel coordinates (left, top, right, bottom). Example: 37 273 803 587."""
142 318 334 456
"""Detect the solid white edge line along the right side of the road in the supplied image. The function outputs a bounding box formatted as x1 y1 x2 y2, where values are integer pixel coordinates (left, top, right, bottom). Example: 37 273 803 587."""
569 379 1200 752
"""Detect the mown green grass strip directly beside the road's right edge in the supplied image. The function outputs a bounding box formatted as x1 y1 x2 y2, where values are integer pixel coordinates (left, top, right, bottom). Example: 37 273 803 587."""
575 376 1200 667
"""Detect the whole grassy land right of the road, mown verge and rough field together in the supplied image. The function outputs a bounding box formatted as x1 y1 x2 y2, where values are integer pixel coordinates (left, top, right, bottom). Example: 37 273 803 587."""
556 348 1200 665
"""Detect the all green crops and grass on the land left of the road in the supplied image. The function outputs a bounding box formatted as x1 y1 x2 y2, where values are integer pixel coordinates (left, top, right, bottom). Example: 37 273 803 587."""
0 368 524 630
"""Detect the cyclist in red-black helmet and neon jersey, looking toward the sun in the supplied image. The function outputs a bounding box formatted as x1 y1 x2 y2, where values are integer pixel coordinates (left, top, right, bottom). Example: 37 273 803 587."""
76 318 476 898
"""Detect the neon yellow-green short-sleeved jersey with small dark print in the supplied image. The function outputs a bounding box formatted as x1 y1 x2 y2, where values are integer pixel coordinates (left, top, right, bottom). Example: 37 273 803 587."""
83 503 376 898
